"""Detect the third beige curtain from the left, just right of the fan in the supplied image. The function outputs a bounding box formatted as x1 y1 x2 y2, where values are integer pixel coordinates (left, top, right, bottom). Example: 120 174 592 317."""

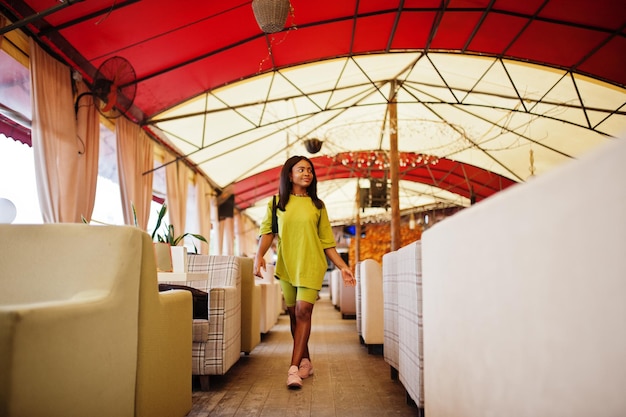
115 118 154 230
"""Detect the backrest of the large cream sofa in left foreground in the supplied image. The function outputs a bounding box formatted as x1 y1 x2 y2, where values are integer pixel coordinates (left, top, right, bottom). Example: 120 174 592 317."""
0 223 144 304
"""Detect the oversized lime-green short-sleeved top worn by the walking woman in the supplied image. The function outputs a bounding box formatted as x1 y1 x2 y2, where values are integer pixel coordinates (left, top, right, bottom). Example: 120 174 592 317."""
259 195 336 290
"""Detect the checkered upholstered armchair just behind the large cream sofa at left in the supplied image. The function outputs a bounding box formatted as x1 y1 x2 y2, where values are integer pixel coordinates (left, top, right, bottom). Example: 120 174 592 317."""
160 255 240 391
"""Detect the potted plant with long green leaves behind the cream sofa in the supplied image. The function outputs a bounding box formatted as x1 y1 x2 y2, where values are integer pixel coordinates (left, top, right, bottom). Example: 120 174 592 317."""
152 204 208 272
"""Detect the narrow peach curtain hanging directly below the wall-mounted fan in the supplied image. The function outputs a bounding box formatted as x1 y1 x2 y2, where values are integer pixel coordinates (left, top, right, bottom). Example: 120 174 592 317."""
76 81 100 221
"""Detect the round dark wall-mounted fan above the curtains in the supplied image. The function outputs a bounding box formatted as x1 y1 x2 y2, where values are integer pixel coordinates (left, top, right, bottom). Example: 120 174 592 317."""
75 56 137 118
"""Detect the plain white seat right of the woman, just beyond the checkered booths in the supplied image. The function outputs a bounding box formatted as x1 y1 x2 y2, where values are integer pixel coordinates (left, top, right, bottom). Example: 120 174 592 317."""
357 259 384 353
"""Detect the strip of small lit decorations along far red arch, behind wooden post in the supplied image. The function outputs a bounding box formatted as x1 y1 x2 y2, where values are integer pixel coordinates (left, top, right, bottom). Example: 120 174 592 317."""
335 150 439 170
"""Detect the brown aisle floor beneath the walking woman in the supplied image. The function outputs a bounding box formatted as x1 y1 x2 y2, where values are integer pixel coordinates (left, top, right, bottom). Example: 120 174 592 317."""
188 290 418 417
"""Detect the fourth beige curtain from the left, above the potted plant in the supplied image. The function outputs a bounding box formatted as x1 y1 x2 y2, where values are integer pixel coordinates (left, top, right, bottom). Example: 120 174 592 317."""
165 154 190 246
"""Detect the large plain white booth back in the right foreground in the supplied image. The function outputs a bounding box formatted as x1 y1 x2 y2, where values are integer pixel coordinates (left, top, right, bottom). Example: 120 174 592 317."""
422 138 626 417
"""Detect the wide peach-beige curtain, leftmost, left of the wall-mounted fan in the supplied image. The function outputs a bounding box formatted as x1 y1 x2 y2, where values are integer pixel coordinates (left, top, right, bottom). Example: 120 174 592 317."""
30 38 81 223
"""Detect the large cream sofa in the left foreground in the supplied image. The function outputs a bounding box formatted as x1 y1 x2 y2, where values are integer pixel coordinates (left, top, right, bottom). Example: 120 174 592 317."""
0 224 192 417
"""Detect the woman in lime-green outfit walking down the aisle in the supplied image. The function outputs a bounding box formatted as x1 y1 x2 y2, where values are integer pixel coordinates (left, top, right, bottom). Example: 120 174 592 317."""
254 156 356 388
